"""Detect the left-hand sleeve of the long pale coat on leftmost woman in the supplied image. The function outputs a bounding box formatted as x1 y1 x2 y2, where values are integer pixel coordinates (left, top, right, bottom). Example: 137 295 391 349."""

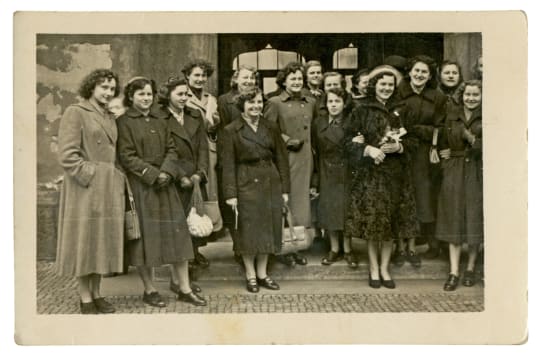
58 107 96 187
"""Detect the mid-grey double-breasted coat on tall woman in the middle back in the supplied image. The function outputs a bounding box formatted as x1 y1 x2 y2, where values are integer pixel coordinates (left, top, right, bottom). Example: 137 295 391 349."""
264 91 317 227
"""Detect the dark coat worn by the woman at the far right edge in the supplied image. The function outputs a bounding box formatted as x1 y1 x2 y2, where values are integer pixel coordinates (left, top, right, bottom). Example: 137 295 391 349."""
436 106 484 244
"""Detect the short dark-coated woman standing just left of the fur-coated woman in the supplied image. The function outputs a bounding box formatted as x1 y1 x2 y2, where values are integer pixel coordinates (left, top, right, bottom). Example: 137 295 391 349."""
311 88 358 268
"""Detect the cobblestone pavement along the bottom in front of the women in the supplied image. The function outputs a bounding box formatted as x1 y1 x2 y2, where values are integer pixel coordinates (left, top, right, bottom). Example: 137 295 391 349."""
37 262 484 314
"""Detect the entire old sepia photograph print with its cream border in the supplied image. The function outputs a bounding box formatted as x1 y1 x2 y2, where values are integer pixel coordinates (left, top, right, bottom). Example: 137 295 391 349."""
15 12 527 344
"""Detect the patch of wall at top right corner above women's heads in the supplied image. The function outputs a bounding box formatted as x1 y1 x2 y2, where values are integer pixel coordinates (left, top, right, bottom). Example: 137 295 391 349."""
444 33 482 80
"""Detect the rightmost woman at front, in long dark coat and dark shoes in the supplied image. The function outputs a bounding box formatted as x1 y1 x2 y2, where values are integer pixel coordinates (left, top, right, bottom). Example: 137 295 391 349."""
436 80 484 291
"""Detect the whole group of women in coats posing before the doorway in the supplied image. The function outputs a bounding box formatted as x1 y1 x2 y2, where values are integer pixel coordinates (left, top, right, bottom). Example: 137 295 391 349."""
56 56 483 313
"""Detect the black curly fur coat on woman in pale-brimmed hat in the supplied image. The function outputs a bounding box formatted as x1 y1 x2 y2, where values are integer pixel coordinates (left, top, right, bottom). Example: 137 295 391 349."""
345 99 418 241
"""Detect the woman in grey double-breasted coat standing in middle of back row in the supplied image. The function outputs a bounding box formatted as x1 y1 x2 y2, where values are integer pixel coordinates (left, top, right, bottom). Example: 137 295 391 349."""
264 62 317 266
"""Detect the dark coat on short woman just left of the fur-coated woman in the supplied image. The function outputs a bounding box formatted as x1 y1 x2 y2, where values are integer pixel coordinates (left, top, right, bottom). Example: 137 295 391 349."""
312 116 350 230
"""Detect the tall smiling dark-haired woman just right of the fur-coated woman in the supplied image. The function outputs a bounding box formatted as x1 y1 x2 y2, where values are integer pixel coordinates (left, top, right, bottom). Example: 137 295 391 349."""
394 56 446 267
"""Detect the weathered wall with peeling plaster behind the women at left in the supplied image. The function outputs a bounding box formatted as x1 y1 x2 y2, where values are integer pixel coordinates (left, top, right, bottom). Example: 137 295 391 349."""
36 34 217 183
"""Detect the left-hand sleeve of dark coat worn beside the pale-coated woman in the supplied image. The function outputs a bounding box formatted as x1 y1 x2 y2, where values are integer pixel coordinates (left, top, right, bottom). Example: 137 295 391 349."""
116 116 160 185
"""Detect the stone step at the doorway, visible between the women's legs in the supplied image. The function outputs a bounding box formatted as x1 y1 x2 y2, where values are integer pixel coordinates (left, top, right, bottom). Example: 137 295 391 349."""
150 238 481 281
